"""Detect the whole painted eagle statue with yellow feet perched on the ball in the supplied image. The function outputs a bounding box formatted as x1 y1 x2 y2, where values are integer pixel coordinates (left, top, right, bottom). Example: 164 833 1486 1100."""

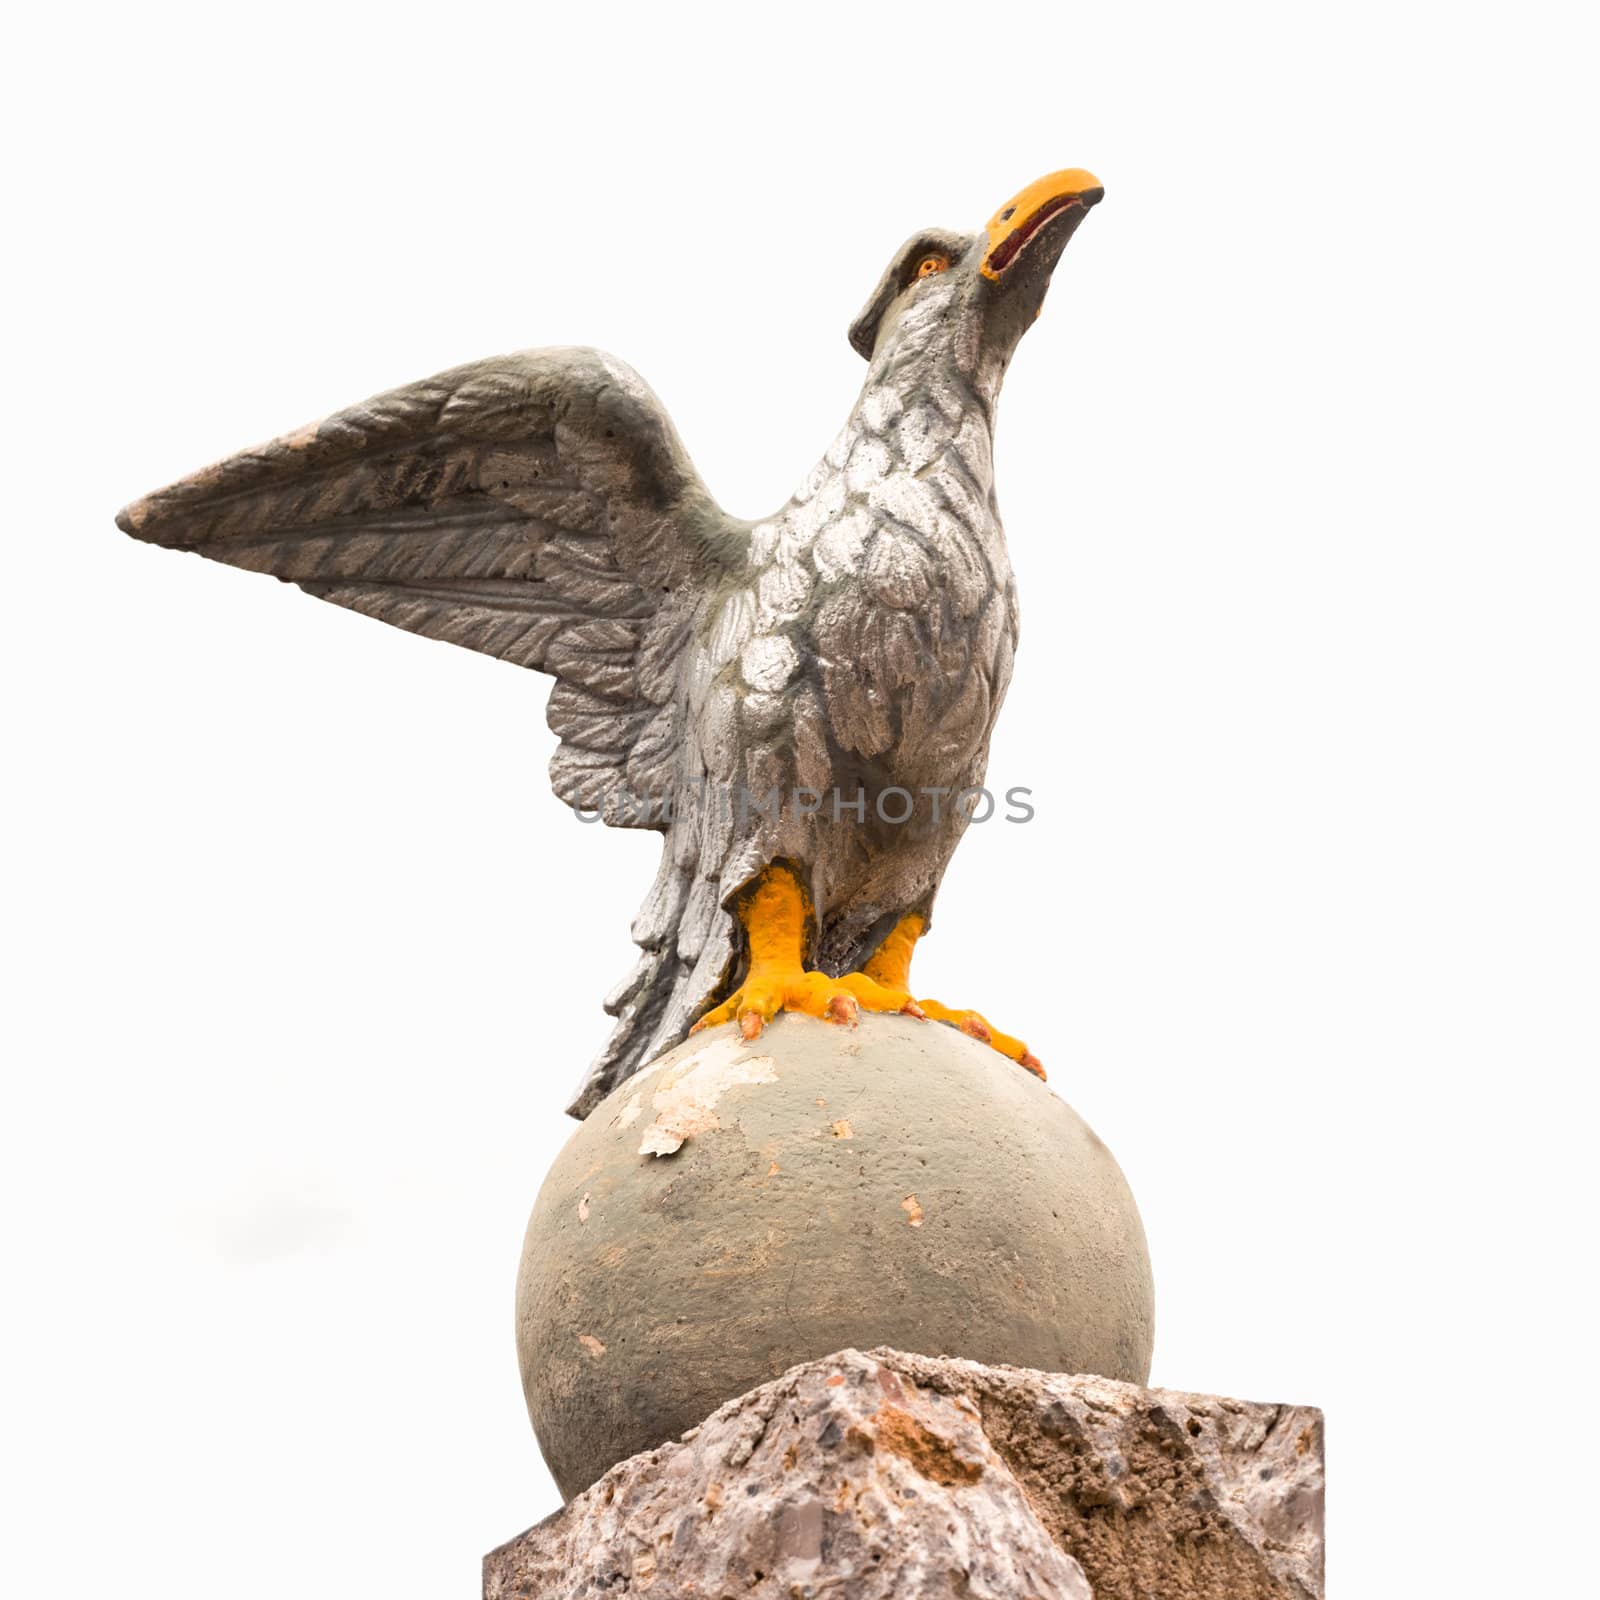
117 170 1102 1117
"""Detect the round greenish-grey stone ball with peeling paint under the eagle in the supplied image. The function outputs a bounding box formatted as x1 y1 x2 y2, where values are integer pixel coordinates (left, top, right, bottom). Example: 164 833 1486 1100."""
517 1014 1154 1499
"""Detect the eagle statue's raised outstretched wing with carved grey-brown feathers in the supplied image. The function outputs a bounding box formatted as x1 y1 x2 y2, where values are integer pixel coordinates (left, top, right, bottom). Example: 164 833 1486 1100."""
117 349 744 826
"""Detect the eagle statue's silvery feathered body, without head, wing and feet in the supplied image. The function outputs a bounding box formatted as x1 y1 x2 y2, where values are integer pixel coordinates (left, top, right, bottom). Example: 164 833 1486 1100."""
611 285 1018 1094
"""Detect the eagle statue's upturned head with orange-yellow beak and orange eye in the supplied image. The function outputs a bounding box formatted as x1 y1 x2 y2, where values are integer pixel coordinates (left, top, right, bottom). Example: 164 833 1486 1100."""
850 166 1106 370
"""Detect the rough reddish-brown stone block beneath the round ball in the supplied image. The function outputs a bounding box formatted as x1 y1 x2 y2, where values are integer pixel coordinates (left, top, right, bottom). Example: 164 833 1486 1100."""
483 1349 1323 1600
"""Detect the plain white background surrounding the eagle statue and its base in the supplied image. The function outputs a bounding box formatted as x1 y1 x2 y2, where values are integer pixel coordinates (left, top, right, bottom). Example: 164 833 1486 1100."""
0 3 1600 1600
